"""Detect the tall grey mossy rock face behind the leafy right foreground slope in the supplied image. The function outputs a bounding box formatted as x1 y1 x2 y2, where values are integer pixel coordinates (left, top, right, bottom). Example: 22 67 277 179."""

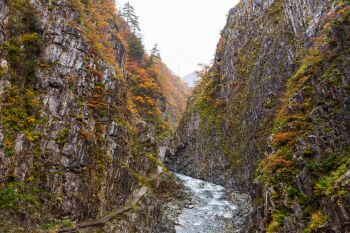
169 1 323 186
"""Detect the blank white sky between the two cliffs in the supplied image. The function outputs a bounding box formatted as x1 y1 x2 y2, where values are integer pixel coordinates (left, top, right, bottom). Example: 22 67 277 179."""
116 0 239 76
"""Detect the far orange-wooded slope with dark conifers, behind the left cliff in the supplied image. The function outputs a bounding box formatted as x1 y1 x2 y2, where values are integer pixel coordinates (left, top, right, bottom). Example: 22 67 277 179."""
118 2 191 137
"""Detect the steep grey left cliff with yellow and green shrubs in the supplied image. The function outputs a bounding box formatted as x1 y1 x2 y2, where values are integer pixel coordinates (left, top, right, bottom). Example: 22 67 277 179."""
0 0 187 232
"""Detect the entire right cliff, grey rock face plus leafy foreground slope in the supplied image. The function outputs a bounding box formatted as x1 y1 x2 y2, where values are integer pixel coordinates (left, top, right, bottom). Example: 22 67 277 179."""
166 0 350 232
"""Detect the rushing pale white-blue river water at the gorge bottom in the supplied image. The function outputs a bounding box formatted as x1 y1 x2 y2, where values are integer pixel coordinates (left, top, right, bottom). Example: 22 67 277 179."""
176 174 249 233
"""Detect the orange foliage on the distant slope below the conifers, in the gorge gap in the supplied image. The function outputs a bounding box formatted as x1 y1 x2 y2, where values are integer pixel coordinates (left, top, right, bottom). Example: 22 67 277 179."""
127 55 191 128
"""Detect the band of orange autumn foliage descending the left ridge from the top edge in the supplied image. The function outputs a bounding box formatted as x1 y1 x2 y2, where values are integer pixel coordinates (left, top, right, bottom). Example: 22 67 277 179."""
71 0 190 138
